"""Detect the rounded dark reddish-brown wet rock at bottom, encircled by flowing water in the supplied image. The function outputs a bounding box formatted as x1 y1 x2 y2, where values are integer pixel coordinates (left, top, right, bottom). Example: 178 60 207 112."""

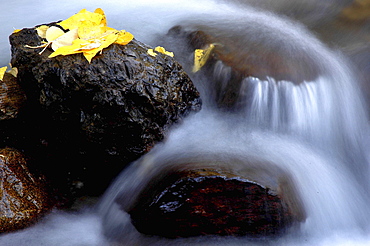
125 163 305 238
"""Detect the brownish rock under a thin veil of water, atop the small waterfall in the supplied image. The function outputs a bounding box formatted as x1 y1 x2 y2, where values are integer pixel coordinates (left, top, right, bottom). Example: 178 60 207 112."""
166 25 320 110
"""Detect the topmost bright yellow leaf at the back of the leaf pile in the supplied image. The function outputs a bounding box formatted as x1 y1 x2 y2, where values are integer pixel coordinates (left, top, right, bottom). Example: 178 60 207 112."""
59 9 106 29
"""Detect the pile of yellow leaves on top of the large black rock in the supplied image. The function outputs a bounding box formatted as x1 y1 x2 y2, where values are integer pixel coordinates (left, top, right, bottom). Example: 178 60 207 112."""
28 8 134 62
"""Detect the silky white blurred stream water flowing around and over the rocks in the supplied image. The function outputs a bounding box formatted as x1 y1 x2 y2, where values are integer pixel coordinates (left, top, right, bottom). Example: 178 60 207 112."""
0 0 370 246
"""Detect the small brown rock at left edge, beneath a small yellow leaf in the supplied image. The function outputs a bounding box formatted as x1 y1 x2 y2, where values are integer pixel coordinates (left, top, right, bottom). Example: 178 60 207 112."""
0 73 26 120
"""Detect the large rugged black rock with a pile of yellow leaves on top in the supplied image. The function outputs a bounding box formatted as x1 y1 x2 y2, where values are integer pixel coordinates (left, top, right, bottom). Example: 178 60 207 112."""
9 23 201 200
